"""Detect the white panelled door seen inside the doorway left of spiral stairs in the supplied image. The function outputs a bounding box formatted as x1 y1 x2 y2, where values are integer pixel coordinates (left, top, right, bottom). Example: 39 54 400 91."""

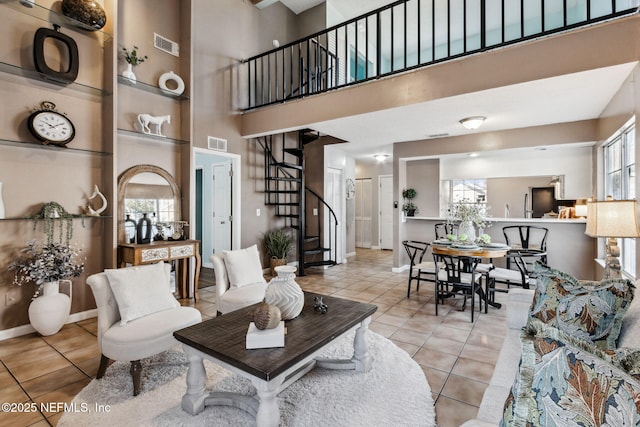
212 161 232 254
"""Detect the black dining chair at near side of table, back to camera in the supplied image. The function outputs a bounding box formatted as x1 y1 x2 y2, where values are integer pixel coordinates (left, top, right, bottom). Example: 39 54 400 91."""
433 253 486 323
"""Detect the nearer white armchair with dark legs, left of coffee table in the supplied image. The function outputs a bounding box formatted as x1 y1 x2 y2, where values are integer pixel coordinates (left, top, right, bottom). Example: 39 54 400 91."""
87 262 202 396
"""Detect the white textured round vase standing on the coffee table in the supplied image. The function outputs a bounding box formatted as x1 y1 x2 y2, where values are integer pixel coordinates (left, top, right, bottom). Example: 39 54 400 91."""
264 265 304 320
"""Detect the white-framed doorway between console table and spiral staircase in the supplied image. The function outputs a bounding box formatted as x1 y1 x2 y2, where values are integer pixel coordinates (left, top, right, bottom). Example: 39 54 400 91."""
191 148 241 268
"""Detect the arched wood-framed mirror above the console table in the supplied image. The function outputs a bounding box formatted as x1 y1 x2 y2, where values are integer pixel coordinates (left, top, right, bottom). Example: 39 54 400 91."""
118 165 181 243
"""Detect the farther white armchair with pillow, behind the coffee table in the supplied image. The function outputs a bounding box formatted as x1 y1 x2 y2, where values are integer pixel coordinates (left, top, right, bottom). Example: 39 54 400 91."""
210 245 267 314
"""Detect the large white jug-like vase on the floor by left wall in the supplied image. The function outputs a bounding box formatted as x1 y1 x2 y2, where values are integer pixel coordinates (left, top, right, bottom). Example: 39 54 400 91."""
29 280 73 336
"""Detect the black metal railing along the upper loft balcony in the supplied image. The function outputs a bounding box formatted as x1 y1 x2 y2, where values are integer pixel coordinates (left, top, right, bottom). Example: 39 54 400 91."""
242 0 640 110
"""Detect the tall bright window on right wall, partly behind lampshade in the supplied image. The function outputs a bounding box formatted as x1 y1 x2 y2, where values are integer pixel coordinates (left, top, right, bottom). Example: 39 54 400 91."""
604 120 636 277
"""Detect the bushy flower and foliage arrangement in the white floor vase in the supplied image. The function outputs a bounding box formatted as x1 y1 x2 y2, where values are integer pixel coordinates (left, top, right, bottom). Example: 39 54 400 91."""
9 240 84 298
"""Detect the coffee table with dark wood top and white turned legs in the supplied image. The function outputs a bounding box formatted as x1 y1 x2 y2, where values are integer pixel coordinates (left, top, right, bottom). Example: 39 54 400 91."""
173 292 377 427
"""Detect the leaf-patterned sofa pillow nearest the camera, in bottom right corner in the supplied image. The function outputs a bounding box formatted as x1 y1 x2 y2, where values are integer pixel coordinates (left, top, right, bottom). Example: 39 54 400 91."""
501 322 640 426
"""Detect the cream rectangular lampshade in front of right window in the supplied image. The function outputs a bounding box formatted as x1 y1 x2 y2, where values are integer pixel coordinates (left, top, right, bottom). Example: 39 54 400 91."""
585 200 640 237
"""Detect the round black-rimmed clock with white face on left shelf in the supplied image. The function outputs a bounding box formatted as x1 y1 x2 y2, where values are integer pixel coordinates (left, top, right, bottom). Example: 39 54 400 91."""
27 101 76 147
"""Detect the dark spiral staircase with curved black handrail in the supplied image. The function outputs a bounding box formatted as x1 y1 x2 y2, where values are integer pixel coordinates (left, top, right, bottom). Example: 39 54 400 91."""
257 129 338 276
